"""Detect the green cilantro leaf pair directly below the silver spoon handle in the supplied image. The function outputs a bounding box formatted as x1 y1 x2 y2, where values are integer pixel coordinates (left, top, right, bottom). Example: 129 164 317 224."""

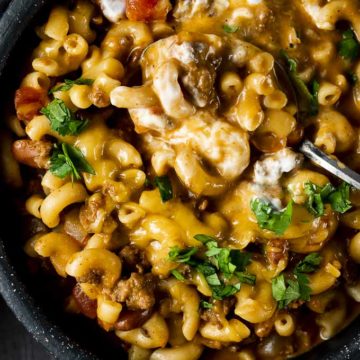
304 182 351 217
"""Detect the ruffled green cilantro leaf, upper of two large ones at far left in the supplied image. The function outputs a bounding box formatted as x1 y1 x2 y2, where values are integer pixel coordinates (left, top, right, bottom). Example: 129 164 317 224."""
40 99 88 136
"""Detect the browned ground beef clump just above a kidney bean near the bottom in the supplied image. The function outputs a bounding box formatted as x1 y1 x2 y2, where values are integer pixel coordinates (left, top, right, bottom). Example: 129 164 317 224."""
112 272 157 310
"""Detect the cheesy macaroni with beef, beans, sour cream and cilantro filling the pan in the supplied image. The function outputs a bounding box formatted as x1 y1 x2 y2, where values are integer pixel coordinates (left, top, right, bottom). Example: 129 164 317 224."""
0 0 360 360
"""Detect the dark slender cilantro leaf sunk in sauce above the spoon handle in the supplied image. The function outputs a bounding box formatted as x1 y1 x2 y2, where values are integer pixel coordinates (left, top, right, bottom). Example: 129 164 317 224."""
280 50 320 116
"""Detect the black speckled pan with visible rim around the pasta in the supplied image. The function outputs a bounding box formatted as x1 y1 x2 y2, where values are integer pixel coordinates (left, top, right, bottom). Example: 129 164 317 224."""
0 0 360 360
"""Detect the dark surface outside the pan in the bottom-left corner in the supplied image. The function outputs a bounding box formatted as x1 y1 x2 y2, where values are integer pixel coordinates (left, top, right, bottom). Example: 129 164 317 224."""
0 296 53 360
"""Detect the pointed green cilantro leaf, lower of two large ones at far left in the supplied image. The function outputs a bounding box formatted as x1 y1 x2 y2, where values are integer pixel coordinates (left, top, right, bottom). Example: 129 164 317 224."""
50 143 95 180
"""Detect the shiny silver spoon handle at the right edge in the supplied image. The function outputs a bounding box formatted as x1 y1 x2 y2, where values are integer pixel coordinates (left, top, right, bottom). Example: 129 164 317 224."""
299 140 360 190
